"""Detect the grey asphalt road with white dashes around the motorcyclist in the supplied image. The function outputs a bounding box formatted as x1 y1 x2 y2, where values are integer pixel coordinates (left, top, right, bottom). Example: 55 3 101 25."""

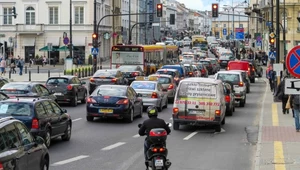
45 76 266 170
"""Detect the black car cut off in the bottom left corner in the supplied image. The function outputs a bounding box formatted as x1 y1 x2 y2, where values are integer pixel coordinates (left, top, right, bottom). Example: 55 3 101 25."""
0 117 50 170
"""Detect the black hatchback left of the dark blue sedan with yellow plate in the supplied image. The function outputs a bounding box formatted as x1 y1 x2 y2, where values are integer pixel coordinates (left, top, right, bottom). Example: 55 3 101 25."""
46 76 87 106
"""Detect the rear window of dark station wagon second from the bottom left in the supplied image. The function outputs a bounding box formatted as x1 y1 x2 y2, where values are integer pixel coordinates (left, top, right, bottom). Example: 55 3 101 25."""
0 102 32 116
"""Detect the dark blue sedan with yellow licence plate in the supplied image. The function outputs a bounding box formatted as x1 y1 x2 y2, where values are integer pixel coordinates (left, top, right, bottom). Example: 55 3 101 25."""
86 84 143 123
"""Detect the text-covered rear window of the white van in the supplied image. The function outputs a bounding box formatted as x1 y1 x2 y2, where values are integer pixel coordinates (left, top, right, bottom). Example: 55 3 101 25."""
177 82 217 98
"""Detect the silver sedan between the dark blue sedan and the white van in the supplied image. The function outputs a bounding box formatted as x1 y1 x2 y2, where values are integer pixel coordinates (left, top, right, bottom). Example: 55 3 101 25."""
130 76 168 112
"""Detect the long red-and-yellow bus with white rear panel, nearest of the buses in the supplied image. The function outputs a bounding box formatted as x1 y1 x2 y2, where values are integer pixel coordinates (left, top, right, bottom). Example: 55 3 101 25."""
110 45 179 75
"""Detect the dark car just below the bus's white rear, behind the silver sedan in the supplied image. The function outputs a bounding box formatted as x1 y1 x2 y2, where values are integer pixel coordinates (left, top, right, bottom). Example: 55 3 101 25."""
118 65 144 85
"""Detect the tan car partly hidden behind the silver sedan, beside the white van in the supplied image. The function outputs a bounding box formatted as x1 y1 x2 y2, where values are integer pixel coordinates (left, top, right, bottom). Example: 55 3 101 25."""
148 74 177 101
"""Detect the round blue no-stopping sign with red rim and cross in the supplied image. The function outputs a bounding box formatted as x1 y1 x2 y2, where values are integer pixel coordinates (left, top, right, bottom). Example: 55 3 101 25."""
286 45 300 78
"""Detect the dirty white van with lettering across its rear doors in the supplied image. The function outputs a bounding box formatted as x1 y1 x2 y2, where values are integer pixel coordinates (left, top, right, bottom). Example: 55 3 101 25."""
173 78 226 132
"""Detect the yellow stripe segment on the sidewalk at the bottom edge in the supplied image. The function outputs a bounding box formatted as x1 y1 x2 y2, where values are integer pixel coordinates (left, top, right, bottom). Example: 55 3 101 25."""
274 141 286 170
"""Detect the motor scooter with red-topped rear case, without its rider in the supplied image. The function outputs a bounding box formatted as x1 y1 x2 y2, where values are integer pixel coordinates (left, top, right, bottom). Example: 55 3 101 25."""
138 123 172 170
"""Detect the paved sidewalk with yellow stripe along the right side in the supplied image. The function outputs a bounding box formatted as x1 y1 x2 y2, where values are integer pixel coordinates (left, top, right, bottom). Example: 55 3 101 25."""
255 78 300 170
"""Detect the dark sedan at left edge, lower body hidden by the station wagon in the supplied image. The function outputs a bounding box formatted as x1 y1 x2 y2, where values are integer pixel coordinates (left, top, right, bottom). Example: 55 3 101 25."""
0 82 57 101
